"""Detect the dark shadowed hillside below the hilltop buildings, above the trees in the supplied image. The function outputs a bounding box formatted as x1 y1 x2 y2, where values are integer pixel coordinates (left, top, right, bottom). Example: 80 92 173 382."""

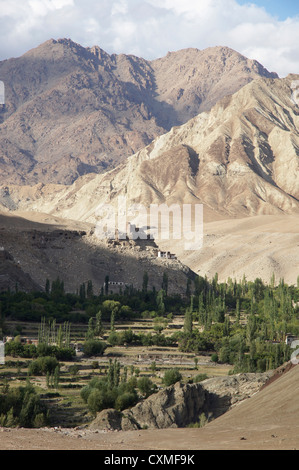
0 213 194 293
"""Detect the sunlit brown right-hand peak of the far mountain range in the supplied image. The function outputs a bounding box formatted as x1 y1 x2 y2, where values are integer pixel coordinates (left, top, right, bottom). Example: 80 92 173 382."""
151 46 278 125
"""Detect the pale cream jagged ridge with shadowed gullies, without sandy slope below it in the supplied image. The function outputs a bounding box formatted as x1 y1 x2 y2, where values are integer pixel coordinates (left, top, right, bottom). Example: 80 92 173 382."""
0 73 299 222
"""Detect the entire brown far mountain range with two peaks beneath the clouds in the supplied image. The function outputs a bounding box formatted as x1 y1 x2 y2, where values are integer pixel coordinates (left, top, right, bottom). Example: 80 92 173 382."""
0 39 277 185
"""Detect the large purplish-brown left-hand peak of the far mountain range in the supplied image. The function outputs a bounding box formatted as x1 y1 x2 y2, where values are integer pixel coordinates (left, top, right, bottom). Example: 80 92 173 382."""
0 39 164 184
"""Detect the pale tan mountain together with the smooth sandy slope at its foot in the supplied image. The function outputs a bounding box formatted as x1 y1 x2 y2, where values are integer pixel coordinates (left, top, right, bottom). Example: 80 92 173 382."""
0 76 299 283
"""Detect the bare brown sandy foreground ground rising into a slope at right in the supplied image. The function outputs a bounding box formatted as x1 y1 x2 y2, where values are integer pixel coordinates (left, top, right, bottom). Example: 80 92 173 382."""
0 367 299 451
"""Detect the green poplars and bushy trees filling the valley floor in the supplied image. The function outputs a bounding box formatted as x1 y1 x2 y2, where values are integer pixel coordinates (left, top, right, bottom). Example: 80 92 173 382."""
0 272 299 426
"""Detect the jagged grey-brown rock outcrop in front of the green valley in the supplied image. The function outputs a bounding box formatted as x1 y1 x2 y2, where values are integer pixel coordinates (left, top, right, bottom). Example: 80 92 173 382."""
89 372 271 431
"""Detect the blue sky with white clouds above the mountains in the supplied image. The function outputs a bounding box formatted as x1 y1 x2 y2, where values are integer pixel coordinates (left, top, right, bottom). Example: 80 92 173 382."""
0 0 299 78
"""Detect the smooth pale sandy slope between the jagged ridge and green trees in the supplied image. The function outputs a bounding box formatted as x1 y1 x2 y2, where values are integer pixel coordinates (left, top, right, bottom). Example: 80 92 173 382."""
159 215 299 284
